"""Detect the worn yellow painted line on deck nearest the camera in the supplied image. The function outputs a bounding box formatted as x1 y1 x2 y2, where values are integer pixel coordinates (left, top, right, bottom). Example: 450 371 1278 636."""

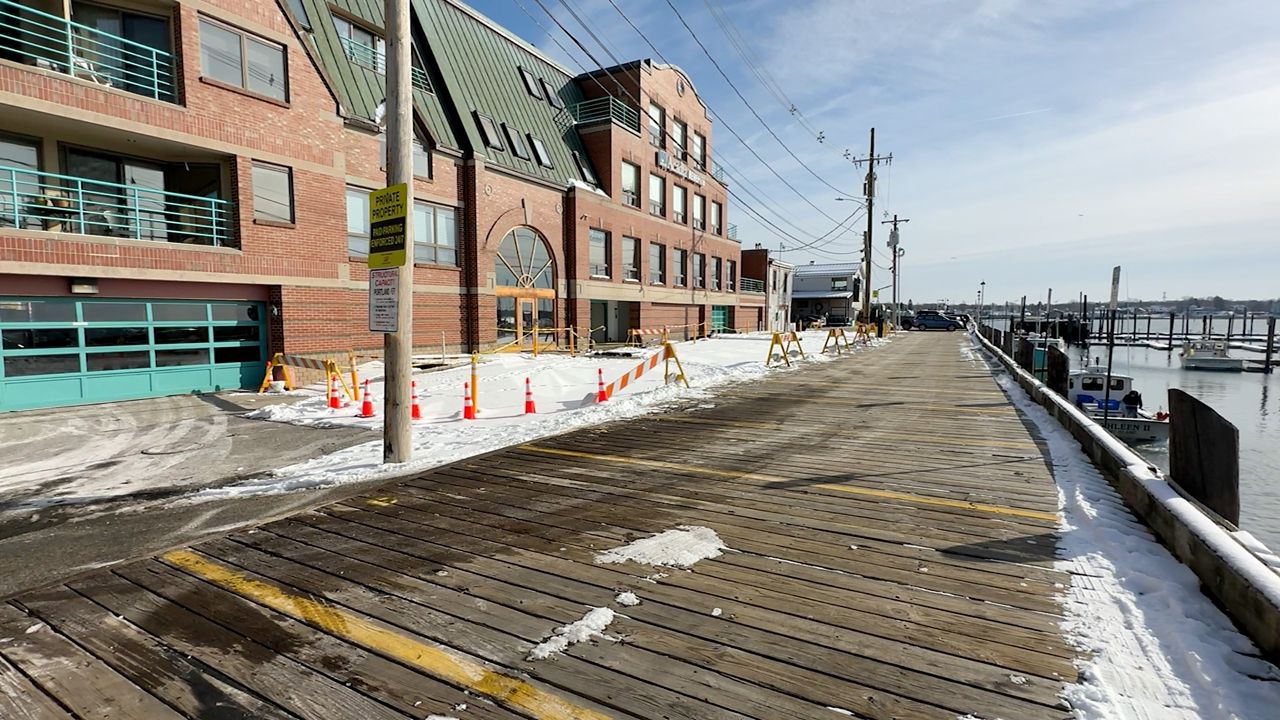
161 550 609 720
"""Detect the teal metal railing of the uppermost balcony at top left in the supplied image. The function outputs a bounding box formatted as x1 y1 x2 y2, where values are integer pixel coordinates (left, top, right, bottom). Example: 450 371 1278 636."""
0 0 177 102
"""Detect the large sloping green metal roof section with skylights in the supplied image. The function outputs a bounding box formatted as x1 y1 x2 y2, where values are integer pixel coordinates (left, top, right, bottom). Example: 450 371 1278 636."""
412 0 590 186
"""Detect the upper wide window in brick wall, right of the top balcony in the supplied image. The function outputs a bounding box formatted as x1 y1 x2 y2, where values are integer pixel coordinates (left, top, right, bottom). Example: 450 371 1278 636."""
200 18 289 102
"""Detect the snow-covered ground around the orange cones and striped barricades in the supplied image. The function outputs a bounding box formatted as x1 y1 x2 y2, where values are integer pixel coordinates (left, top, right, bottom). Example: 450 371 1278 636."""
175 332 890 502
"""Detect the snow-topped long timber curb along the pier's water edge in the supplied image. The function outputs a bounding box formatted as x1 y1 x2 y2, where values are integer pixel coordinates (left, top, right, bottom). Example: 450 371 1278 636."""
973 322 1280 661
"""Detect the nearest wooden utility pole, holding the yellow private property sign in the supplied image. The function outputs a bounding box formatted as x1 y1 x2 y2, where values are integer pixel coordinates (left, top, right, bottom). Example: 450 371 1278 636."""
383 0 413 462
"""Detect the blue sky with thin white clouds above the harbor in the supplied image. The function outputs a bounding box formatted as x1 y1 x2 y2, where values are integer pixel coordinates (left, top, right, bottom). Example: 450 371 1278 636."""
471 0 1280 302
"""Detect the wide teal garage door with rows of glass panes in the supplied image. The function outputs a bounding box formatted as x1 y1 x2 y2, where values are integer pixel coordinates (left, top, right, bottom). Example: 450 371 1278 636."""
0 297 266 411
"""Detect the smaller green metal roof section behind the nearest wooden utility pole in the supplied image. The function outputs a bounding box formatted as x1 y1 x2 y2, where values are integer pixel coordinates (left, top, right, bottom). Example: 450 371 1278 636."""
291 0 463 150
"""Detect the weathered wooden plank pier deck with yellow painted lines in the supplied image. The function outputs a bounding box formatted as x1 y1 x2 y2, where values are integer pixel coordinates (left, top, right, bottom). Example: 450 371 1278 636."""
0 333 1075 720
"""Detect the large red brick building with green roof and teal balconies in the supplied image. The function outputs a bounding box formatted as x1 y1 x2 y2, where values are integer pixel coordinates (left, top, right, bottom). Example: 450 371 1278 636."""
0 0 755 410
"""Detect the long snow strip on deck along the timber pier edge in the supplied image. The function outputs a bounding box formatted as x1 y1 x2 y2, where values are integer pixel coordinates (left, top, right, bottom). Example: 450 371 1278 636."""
997 361 1280 720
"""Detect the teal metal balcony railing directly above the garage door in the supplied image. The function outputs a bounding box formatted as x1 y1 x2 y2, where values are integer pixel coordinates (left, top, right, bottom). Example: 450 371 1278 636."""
0 165 232 247
